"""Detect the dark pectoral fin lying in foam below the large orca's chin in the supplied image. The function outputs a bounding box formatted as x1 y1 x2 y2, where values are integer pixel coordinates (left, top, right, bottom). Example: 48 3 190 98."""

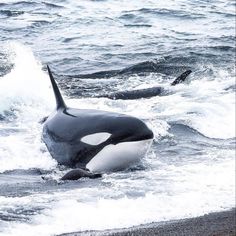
61 168 102 180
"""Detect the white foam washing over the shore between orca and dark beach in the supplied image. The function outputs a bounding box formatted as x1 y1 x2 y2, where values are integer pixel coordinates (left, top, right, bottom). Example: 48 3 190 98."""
0 156 234 236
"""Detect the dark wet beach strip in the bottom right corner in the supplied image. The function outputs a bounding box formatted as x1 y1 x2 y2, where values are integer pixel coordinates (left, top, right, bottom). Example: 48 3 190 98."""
60 208 236 236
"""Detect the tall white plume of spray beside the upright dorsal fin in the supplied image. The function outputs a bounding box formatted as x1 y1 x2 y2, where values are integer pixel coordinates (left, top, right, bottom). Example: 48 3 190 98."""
0 43 53 116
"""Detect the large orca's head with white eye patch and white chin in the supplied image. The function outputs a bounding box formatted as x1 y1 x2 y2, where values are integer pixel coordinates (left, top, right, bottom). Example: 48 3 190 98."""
71 108 153 172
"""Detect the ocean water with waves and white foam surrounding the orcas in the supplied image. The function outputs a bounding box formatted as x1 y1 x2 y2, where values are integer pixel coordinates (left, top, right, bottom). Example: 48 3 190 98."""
0 0 235 236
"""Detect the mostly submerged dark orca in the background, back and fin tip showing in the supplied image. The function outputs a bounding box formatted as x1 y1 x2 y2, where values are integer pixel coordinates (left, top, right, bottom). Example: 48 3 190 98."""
94 70 192 100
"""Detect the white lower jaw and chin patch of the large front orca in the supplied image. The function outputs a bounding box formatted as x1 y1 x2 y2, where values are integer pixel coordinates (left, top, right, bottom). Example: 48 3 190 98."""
86 139 153 172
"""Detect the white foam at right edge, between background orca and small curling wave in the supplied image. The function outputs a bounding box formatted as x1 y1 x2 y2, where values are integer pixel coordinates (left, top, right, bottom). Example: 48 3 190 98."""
141 73 235 139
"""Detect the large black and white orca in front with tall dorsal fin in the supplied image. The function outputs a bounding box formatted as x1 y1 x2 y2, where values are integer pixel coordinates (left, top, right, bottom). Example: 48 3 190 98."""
42 67 153 179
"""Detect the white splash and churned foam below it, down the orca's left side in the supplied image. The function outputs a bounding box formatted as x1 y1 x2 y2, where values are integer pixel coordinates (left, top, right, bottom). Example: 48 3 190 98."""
0 43 55 172
